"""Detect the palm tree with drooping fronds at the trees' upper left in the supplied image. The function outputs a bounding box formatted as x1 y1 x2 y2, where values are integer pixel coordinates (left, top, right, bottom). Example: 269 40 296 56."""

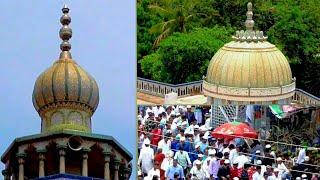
149 0 200 48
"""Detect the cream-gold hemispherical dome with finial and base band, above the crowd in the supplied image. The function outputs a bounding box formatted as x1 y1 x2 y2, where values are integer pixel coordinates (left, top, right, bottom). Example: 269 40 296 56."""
203 3 295 103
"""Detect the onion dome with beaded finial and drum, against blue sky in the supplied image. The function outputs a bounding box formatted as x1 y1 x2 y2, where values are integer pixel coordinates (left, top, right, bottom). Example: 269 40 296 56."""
32 6 99 132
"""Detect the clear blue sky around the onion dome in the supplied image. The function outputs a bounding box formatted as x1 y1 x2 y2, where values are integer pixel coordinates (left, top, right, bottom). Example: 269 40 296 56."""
0 0 136 177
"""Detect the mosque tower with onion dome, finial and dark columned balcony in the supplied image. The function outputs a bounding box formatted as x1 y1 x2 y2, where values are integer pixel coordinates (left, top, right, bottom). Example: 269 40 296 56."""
1 6 132 180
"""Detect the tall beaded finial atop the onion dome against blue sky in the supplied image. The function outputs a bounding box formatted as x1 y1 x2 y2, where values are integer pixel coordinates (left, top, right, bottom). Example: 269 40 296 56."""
59 5 72 59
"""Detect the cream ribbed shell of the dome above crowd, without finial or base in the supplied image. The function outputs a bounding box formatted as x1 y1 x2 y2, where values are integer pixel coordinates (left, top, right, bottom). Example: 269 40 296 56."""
206 41 292 88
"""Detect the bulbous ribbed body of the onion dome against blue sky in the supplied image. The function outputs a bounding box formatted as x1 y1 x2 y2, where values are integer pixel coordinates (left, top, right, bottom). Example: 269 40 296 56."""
33 58 99 114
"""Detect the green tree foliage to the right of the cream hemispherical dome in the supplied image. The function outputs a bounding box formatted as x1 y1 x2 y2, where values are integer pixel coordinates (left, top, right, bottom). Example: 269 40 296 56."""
268 0 320 96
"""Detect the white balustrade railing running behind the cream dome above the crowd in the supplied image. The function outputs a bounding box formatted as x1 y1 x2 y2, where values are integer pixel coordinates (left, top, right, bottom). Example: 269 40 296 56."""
137 78 320 105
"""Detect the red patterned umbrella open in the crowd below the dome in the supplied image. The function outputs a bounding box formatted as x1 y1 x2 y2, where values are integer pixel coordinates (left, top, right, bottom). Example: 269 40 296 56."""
211 121 258 139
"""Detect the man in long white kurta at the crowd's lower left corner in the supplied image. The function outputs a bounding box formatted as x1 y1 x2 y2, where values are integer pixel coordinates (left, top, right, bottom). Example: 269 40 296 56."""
138 142 154 174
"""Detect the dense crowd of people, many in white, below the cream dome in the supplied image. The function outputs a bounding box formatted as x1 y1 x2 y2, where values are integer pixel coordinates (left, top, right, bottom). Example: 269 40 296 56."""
138 106 320 180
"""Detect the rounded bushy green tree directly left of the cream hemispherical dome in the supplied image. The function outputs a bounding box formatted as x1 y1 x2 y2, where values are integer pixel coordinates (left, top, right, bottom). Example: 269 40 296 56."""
140 26 233 84
